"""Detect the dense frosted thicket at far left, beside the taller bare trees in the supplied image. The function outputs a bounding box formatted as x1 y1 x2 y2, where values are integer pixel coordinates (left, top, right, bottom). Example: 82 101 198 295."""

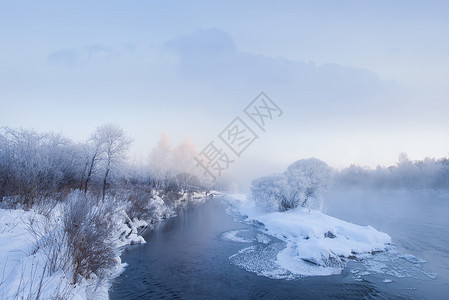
0 128 81 208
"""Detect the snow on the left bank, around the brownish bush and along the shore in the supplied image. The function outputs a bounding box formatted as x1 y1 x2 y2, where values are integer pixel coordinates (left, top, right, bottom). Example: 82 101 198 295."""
0 193 210 300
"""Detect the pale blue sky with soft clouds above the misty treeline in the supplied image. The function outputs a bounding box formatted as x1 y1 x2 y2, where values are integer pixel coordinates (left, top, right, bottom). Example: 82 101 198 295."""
0 0 449 188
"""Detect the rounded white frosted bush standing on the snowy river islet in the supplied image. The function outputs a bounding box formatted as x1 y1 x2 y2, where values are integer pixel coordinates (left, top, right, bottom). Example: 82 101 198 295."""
251 158 332 211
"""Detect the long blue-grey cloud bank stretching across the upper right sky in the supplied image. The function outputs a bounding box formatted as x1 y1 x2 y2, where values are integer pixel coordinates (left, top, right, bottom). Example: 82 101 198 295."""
165 28 392 110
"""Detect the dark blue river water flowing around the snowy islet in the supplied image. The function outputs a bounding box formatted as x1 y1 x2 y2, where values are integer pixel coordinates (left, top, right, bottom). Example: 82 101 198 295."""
109 191 449 299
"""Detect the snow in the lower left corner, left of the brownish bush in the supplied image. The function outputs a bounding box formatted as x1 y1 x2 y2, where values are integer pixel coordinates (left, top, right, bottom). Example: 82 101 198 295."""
0 209 92 299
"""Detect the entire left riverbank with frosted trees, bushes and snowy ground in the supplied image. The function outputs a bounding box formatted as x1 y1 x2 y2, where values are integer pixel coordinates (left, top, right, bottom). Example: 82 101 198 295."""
0 125 208 299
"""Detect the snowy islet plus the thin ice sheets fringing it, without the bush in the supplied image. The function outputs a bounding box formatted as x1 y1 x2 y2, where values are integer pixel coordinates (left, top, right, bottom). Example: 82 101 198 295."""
222 194 436 281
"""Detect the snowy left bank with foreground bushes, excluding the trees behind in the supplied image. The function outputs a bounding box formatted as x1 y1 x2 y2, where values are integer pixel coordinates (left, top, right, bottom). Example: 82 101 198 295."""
0 191 210 300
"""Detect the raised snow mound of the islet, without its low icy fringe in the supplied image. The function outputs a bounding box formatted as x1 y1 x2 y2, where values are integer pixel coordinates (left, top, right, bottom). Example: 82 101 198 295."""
254 208 391 269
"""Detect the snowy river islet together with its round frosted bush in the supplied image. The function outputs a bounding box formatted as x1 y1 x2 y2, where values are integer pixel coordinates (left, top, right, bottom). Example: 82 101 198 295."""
224 159 391 277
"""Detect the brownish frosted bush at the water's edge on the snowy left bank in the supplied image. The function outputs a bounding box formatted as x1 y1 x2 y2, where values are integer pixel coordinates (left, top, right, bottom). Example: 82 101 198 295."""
64 191 119 283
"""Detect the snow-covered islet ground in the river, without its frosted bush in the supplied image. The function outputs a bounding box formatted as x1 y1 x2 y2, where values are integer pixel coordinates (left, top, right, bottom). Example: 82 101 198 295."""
226 194 391 277
